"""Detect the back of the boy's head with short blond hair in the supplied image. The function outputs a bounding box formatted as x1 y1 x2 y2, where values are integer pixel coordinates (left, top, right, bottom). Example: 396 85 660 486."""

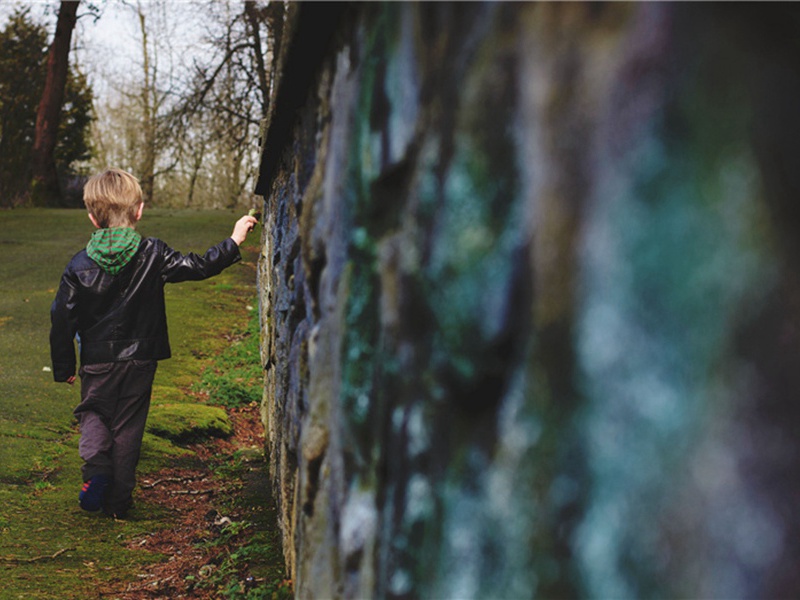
83 169 143 227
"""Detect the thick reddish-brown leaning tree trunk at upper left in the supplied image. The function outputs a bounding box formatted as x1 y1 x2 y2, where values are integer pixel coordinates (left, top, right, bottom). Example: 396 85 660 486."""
31 0 79 204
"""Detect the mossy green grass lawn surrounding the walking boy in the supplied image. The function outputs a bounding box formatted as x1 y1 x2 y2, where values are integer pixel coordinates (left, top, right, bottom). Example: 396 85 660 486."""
0 209 268 599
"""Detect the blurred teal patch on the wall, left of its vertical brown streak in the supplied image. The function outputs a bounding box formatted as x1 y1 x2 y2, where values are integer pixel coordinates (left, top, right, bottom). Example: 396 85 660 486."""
416 17 526 404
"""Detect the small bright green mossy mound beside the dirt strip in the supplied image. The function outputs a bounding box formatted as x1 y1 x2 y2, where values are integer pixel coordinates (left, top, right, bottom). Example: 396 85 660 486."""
147 403 233 443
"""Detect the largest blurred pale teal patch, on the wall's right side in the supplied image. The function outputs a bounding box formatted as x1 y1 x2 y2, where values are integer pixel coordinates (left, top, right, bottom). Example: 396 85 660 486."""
576 21 777 597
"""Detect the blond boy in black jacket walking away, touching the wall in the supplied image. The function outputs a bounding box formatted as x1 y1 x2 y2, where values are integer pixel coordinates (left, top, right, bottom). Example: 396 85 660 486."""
50 169 256 518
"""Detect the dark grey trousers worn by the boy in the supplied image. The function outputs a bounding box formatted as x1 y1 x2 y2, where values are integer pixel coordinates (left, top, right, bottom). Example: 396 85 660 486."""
75 360 158 512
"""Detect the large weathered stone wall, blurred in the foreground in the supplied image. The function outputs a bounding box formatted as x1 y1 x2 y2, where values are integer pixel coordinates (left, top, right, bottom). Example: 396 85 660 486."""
253 3 800 598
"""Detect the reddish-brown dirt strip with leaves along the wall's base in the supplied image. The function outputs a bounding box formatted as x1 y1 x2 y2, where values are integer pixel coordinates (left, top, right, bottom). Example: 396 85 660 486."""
100 406 292 600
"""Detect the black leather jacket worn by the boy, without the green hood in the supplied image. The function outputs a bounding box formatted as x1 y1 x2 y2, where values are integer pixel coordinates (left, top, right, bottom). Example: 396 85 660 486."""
50 238 241 381
